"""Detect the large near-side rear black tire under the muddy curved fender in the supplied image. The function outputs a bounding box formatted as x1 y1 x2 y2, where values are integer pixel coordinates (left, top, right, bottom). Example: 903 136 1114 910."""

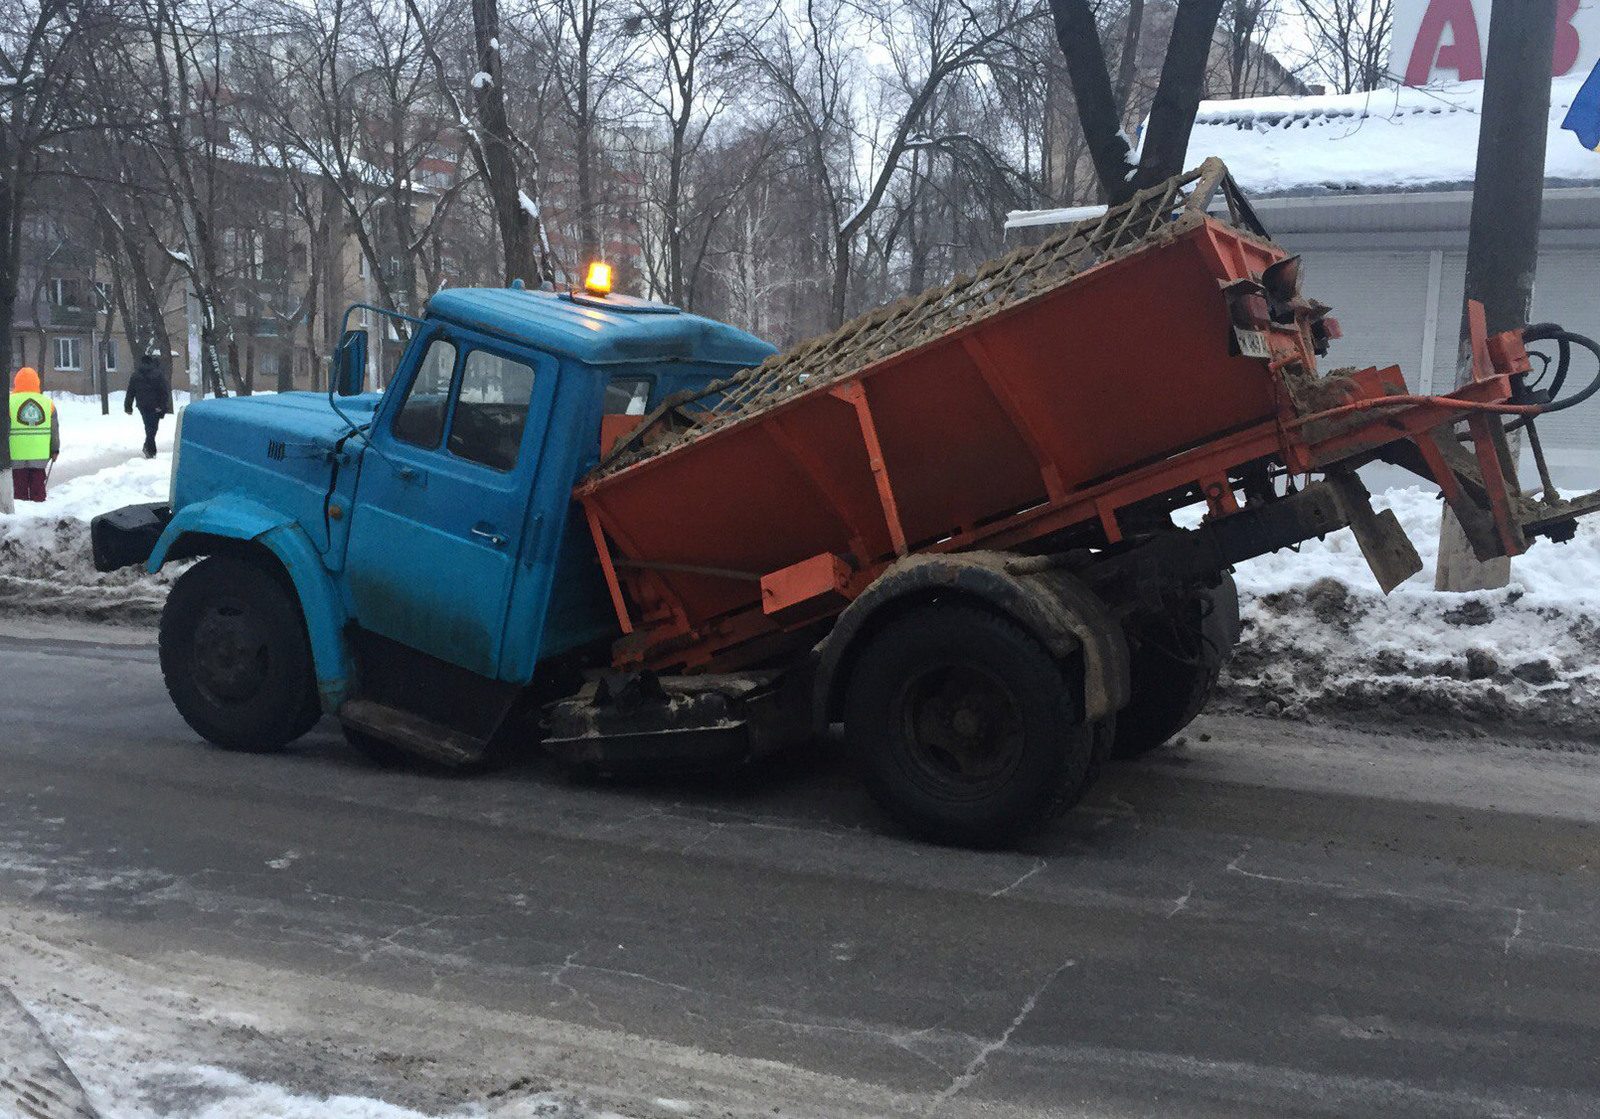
845 604 1094 847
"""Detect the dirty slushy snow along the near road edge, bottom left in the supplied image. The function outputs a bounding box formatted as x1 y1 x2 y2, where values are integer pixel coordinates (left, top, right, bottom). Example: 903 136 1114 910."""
0 902 742 1119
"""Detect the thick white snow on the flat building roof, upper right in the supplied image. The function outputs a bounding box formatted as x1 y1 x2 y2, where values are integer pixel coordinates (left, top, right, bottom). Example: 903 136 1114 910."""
1186 75 1600 195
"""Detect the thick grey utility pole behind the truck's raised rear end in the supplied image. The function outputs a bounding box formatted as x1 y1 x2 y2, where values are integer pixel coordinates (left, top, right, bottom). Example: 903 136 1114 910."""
1434 0 1557 591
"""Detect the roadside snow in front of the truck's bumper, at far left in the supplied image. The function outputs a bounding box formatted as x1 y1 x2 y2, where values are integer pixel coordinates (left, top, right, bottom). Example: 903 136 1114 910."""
0 392 189 623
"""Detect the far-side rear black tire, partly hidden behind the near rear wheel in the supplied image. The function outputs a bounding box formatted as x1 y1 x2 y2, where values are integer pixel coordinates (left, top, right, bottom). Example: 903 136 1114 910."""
1112 575 1238 759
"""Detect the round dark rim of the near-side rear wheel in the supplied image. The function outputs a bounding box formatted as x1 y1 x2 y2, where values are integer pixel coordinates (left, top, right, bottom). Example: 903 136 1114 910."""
896 664 1024 800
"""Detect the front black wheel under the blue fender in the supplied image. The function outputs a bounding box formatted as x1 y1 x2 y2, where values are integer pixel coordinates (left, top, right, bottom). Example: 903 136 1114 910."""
160 555 322 754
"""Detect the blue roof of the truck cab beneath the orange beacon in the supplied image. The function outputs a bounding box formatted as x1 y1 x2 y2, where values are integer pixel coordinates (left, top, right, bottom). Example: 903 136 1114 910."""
427 288 776 368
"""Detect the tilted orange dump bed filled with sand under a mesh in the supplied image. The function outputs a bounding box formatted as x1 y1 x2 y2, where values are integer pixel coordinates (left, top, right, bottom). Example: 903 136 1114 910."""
576 163 1536 669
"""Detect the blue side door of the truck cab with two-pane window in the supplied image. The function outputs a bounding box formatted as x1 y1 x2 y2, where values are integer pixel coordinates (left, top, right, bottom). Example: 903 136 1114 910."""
346 330 557 677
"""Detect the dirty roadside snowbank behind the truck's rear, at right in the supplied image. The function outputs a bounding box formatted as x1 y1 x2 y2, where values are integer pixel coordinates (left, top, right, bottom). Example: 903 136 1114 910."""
1224 487 1600 736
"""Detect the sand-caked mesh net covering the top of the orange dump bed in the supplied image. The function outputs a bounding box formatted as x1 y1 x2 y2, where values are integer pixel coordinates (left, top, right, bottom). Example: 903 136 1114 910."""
590 158 1266 477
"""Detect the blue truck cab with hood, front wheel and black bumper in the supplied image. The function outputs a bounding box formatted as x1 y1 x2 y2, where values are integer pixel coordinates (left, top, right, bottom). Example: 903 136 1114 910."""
91 285 774 764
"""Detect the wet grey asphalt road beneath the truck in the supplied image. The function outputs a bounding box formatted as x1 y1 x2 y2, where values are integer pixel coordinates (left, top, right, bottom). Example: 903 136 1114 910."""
0 623 1600 1117
